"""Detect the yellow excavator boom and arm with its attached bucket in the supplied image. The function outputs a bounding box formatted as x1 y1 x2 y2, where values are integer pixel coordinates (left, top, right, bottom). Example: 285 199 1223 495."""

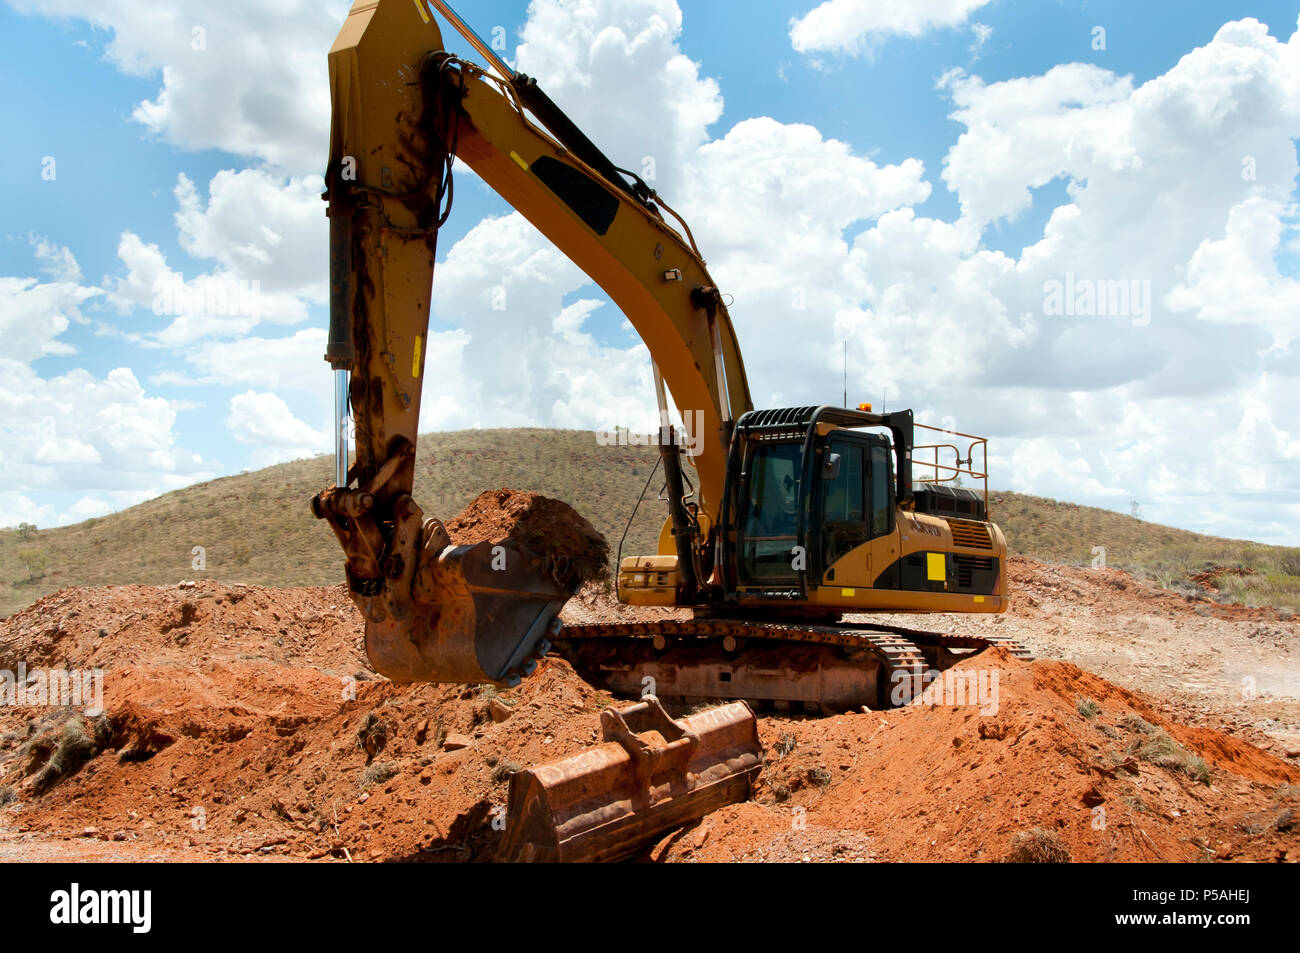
312 0 751 683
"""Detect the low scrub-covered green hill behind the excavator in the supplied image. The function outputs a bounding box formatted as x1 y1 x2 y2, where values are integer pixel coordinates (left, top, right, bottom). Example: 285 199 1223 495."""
0 429 1300 616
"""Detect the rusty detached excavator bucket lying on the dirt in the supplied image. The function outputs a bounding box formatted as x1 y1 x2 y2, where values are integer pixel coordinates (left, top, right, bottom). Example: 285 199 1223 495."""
497 696 763 862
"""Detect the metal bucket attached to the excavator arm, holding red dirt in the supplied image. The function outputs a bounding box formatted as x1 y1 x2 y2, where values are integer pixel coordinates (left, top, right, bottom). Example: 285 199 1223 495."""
365 542 573 685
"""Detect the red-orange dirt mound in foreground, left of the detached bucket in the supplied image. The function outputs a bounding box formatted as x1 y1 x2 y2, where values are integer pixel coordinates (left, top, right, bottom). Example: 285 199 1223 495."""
0 650 610 862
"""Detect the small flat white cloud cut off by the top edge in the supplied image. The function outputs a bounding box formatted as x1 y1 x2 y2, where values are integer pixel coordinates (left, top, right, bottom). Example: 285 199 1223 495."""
790 0 989 53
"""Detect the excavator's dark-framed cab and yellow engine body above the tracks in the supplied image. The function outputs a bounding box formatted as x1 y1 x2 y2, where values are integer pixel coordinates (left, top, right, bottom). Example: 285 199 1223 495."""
620 407 1006 619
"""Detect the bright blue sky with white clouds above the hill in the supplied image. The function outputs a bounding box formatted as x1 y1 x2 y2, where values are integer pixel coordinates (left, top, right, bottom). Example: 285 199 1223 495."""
0 0 1300 543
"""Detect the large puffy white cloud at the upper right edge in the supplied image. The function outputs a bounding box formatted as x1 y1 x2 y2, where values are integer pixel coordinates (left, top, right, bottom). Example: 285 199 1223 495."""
940 20 1300 230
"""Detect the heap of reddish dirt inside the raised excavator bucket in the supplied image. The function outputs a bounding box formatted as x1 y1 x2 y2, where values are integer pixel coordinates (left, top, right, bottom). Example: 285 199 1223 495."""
446 490 610 588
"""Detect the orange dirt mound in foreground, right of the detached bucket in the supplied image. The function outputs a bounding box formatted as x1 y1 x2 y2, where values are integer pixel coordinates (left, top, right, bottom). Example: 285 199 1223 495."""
657 650 1300 861
